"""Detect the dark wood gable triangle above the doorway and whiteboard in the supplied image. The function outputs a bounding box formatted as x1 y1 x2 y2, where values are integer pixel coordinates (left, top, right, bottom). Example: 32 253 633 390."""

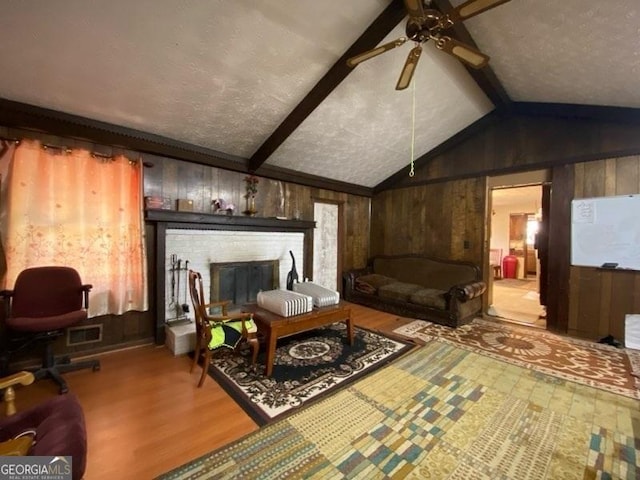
397 115 640 186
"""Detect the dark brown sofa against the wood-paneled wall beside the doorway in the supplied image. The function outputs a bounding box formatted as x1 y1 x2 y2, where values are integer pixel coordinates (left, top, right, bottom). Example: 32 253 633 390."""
343 254 487 328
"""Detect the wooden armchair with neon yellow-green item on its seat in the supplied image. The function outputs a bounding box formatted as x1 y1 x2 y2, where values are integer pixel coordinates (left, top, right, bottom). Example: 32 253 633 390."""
189 270 259 387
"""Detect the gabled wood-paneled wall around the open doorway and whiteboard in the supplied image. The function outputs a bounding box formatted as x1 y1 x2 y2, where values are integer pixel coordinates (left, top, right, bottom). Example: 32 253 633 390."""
371 109 640 340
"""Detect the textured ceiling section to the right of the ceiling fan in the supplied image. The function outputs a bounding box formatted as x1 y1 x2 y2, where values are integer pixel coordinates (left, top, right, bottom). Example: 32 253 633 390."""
451 0 640 107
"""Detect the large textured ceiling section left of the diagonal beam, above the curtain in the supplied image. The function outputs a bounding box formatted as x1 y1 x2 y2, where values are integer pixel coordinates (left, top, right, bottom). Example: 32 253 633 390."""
0 0 386 157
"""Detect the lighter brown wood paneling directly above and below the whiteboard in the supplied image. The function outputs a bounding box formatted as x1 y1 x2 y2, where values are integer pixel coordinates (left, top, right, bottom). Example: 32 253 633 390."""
567 156 640 340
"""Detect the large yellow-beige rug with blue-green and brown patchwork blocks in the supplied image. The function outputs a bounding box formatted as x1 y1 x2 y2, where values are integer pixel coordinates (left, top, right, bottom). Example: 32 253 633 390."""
160 342 640 480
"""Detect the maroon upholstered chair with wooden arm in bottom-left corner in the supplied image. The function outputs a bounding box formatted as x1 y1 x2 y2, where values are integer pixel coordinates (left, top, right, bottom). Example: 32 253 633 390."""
0 372 87 480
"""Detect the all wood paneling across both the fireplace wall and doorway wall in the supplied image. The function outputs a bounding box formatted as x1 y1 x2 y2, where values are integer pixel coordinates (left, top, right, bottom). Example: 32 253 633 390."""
5 110 640 348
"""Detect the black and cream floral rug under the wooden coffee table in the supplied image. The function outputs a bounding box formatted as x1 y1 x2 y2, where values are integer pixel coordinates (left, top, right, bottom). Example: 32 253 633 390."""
209 322 415 425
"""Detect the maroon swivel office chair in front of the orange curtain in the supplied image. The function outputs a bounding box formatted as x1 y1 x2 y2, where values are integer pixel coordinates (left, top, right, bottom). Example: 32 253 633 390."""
0 266 100 393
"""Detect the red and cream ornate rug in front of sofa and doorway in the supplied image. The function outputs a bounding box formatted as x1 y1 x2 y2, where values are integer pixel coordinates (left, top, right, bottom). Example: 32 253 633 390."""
394 318 640 399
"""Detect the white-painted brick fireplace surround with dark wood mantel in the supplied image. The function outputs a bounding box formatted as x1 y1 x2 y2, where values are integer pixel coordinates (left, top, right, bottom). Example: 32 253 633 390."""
145 210 315 344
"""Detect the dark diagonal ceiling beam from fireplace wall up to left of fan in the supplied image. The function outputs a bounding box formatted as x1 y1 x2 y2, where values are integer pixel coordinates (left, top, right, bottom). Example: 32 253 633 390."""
249 0 406 172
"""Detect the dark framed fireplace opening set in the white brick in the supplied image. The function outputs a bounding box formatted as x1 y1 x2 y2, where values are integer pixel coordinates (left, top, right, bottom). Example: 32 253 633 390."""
210 260 280 309
